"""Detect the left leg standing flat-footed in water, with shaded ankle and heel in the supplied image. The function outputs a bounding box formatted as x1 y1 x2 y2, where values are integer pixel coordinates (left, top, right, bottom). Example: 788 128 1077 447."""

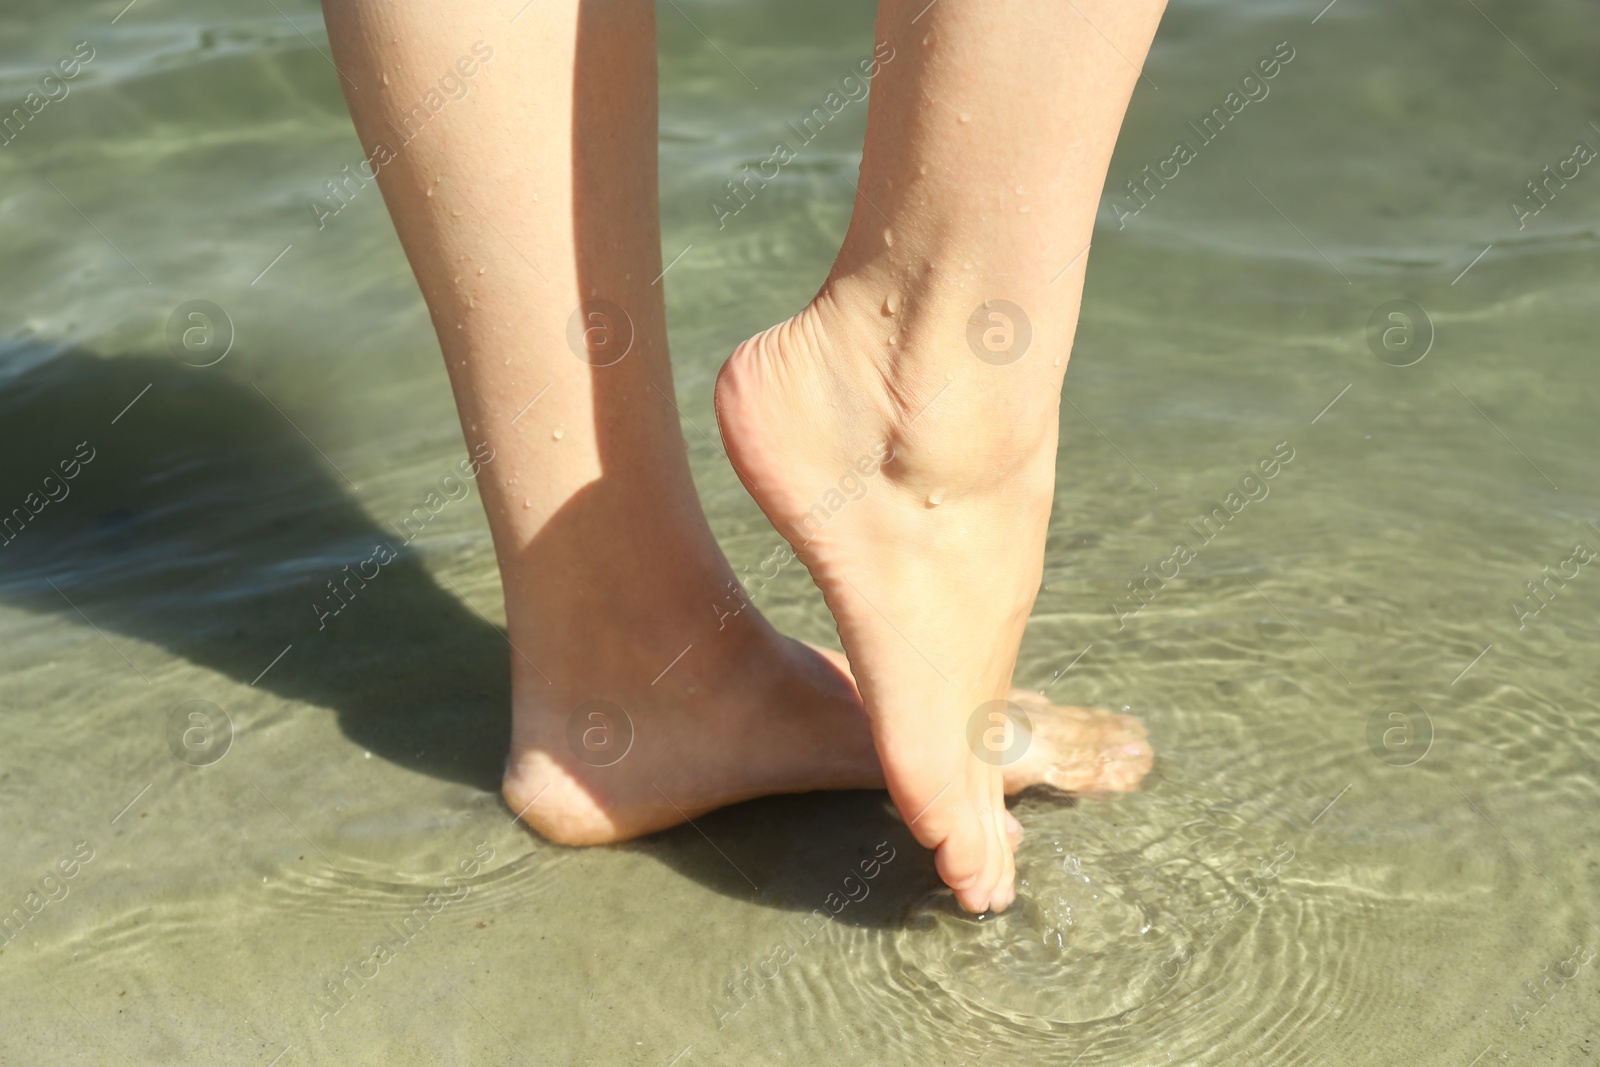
316 0 882 843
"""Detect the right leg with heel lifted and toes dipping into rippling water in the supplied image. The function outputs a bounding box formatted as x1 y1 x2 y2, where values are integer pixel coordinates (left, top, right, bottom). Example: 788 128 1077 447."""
717 0 1163 912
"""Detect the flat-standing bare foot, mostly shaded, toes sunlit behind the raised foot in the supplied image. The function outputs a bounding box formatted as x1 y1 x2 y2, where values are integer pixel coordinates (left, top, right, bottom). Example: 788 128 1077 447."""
504 608 1150 848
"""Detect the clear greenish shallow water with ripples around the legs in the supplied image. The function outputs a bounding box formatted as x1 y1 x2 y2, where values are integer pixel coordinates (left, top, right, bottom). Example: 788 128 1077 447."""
0 0 1600 1067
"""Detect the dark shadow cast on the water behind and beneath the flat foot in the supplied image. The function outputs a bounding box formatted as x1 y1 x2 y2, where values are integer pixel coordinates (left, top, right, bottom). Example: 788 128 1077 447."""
0 350 938 925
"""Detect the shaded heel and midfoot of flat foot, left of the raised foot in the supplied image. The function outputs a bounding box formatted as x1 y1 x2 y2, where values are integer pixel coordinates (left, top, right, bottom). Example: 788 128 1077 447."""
502 608 882 845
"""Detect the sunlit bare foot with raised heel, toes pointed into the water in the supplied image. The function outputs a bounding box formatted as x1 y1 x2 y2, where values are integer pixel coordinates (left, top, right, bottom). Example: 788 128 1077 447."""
717 272 1081 912
